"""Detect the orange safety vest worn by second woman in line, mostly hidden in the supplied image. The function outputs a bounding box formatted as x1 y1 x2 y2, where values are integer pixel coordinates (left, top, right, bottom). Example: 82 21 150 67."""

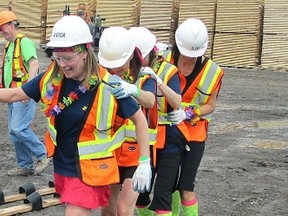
116 69 158 167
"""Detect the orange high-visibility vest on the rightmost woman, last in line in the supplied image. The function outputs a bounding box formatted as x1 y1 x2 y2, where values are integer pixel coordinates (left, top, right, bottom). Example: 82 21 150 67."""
178 59 223 142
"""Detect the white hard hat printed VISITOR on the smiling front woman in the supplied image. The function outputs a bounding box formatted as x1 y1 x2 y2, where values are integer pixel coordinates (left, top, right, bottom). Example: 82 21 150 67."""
47 15 93 47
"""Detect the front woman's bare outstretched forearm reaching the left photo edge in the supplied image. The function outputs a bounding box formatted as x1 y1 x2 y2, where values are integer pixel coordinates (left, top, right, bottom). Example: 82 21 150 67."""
0 87 29 103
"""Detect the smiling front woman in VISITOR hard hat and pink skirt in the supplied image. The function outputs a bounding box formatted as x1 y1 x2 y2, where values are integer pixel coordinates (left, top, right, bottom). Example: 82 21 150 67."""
0 15 149 216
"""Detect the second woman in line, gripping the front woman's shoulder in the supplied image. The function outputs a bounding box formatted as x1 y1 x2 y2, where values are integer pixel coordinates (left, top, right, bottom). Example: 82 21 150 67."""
98 26 157 216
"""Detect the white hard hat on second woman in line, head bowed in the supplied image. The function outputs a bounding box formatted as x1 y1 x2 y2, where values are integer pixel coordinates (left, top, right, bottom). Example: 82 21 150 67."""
98 26 135 68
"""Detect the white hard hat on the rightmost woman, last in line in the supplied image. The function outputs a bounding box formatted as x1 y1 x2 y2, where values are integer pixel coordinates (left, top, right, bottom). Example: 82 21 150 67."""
175 18 208 57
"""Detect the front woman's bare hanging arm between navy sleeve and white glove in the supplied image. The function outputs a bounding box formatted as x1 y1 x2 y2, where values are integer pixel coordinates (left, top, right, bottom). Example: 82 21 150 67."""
130 109 150 157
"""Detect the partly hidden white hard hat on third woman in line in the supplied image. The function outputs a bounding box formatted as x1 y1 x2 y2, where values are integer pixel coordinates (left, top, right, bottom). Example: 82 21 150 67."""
129 26 156 58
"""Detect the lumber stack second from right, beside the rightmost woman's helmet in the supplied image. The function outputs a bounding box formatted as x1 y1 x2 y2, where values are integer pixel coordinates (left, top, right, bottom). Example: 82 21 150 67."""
212 0 263 68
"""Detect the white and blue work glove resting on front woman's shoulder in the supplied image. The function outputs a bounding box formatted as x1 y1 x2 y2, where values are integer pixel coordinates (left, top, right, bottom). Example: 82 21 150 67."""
109 75 139 99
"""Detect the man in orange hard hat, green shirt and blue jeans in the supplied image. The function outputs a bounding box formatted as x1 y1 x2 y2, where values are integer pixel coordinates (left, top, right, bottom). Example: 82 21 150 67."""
0 11 51 176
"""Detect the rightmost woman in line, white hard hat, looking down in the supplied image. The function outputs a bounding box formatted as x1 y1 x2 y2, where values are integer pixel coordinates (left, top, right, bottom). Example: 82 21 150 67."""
149 18 224 216
